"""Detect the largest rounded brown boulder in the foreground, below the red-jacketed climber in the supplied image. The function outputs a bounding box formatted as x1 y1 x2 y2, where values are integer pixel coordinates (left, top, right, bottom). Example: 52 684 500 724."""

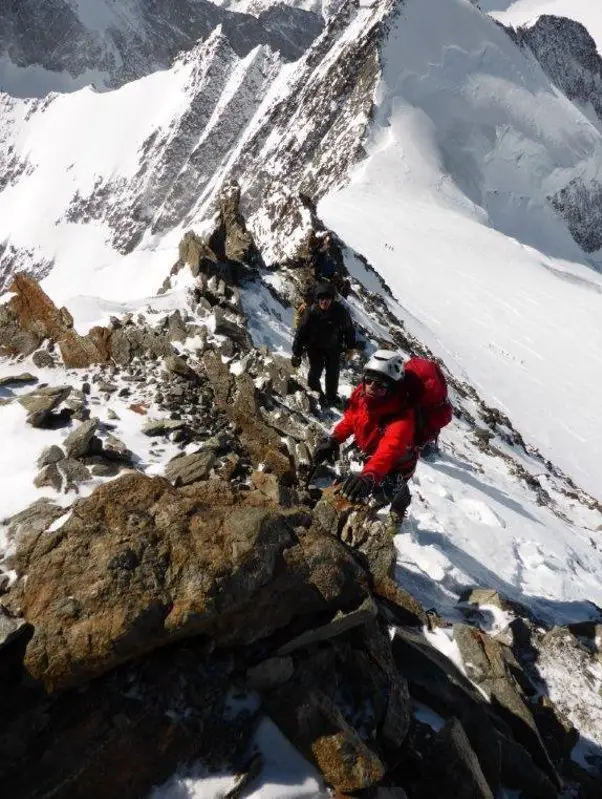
11 474 369 690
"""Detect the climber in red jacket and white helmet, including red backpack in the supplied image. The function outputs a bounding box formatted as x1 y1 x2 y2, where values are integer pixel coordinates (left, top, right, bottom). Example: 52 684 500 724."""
313 350 452 522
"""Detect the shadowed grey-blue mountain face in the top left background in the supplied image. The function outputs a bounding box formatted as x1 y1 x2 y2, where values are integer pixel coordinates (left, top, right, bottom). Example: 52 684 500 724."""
0 0 323 94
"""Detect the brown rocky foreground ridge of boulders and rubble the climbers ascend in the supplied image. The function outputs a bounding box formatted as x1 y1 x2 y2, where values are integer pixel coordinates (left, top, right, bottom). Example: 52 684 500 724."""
0 195 602 799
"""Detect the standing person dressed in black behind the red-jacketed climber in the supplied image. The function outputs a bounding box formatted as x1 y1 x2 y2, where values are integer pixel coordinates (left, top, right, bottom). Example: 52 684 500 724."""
291 283 355 405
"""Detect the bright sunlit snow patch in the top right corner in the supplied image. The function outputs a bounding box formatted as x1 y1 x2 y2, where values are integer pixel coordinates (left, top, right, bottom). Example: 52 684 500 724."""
488 0 602 52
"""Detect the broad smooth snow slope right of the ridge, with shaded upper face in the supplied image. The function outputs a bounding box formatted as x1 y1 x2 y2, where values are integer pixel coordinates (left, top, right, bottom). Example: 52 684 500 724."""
319 0 602 497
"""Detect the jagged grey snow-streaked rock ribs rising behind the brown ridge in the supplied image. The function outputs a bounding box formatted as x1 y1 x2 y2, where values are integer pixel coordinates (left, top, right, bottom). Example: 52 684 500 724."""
52 0 390 262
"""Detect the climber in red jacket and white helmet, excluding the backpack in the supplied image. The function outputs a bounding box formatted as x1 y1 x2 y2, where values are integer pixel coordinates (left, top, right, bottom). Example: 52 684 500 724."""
314 350 418 520
